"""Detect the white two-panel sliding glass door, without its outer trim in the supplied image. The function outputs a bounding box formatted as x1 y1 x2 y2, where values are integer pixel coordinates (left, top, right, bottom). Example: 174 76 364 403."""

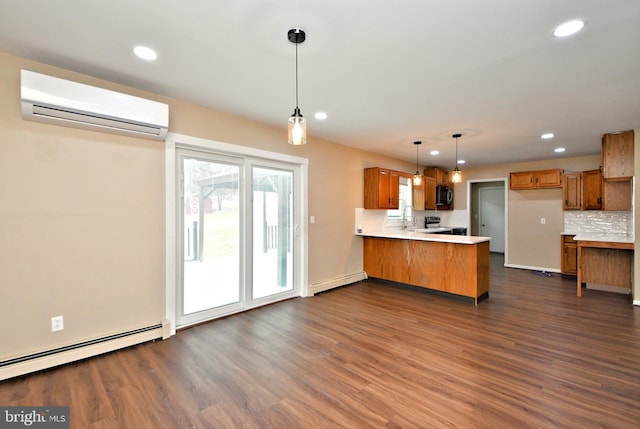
176 148 299 326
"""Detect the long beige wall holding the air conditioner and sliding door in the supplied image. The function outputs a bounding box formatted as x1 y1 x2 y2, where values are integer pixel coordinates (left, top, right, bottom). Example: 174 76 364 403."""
0 54 412 360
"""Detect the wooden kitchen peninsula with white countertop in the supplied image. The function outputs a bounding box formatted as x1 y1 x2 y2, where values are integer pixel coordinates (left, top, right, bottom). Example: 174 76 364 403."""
357 231 491 305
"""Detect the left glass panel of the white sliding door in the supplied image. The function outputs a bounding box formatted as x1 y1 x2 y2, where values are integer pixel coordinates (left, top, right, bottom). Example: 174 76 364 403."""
181 157 241 316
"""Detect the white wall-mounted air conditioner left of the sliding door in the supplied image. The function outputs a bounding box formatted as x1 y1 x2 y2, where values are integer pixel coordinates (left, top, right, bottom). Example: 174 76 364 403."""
20 70 169 140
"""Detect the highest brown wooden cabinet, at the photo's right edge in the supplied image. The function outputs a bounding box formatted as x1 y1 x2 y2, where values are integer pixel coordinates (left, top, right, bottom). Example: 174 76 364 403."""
602 130 634 180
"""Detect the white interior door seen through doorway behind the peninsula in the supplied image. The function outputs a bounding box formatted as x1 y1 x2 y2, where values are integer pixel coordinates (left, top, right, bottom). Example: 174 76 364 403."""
478 187 505 253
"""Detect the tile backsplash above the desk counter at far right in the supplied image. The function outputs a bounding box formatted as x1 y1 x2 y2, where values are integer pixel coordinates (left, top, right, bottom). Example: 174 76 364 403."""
564 210 633 234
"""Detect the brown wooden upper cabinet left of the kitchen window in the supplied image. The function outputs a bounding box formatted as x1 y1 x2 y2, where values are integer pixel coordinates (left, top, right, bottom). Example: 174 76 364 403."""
364 167 400 210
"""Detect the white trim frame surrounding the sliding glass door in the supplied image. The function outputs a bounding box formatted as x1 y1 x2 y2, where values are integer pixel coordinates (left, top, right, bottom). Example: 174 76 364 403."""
165 133 310 335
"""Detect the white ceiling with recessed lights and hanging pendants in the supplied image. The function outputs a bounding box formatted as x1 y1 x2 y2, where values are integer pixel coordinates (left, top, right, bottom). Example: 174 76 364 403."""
0 0 640 166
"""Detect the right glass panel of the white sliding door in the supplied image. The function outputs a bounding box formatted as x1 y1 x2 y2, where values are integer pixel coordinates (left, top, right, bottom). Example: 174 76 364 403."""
252 167 294 300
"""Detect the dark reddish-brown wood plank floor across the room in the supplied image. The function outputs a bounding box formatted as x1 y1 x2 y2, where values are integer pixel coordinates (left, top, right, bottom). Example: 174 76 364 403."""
0 255 640 429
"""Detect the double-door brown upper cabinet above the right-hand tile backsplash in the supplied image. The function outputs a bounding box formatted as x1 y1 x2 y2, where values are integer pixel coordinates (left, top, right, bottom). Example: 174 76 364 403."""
562 169 602 210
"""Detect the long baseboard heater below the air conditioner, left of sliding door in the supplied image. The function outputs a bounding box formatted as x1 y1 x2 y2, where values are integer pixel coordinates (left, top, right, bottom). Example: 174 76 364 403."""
0 321 169 380
